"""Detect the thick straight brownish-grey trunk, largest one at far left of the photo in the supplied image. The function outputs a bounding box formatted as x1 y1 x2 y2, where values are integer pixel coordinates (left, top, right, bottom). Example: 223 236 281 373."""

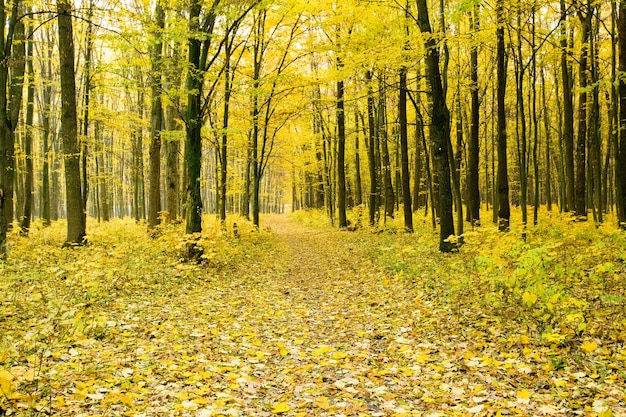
57 0 86 245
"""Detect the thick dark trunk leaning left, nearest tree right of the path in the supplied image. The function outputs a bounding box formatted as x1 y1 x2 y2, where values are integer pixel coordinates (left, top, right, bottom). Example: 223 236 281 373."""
417 0 456 252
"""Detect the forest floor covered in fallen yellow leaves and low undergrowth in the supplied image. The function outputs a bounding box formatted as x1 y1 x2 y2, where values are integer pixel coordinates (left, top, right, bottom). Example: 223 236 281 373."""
0 213 626 417
